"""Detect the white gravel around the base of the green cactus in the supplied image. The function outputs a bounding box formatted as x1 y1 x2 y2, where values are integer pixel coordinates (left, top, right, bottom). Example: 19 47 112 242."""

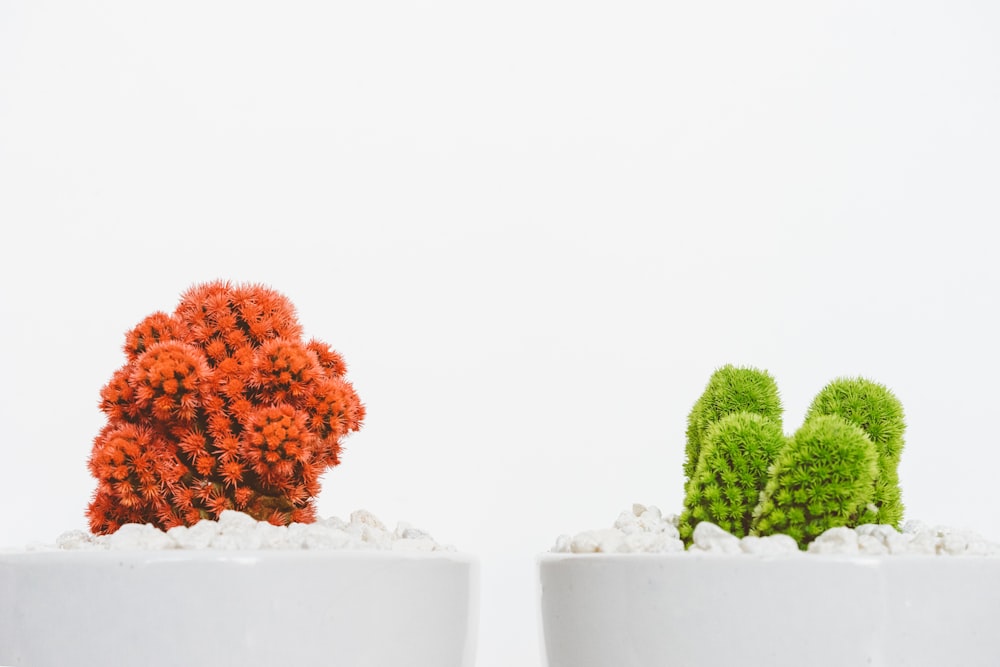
552 504 1000 557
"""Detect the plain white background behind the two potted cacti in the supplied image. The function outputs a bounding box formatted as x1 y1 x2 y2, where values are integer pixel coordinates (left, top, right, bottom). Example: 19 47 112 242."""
0 0 1000 667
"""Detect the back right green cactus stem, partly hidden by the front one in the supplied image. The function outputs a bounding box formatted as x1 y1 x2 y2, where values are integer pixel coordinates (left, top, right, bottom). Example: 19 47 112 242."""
806 378 906 529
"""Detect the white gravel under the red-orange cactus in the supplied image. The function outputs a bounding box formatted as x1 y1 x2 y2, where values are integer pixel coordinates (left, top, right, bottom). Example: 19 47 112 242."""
30 510 455 552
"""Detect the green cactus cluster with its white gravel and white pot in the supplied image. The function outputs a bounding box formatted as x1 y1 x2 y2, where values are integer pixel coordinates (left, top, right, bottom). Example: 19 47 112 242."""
539 365 1000 667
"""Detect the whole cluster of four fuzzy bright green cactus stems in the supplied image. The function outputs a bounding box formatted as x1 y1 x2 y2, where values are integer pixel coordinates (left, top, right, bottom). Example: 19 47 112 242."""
679 366 905 548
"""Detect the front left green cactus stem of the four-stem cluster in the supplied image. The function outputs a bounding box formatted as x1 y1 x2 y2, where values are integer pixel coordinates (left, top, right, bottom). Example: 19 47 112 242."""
678 412 785 543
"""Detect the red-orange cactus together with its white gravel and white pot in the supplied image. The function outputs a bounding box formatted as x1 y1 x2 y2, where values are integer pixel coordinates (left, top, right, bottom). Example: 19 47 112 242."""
0 281 478 667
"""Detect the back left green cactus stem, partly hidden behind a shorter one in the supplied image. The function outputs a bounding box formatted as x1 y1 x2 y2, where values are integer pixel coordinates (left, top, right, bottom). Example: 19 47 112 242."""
684 364 782 480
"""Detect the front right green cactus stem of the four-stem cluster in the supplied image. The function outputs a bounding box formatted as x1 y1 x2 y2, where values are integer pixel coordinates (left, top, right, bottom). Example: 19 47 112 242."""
751 415 878 548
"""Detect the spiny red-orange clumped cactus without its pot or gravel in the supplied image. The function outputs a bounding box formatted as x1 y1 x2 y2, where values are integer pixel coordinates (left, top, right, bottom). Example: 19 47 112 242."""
87 281 365 534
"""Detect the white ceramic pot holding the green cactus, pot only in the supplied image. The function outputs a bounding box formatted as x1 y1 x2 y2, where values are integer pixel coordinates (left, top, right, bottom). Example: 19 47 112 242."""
539 553 1000 667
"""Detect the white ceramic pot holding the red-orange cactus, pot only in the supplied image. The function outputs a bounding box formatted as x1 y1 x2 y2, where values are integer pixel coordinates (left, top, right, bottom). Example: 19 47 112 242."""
0 550 479 667
